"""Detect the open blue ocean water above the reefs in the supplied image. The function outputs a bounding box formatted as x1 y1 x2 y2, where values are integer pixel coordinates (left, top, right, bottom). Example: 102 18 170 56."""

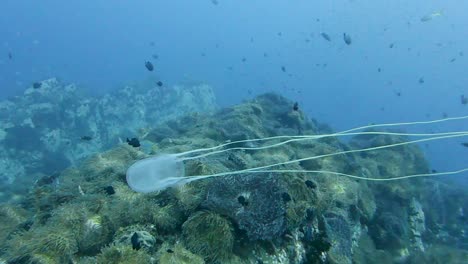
0 0 468 182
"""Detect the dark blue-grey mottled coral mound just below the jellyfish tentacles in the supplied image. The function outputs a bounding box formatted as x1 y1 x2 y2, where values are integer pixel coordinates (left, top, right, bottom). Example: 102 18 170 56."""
202 173 286 240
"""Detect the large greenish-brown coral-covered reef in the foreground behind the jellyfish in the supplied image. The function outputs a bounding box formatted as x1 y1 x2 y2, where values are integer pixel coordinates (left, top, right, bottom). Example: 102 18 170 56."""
0 94 468 264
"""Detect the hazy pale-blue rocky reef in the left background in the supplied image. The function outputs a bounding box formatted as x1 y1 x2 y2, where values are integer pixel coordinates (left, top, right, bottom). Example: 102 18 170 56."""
0 79 216 201
